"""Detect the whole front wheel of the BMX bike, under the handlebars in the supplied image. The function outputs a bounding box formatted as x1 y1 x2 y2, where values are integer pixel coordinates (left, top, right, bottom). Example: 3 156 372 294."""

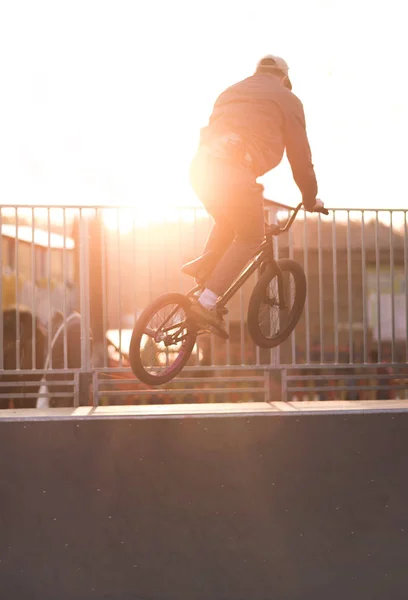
248 258 306 348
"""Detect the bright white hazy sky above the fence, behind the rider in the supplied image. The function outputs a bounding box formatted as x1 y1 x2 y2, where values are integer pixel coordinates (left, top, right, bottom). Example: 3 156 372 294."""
0 0 408 211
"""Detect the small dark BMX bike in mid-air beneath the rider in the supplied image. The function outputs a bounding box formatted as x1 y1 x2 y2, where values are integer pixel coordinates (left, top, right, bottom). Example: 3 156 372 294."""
129 200 329 385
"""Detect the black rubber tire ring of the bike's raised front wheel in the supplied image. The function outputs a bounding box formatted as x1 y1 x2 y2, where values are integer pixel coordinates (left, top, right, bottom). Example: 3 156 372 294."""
248 258 306 348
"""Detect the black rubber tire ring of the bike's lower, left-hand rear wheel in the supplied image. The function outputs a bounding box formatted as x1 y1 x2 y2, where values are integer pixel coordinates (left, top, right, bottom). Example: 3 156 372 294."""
129 292 197 386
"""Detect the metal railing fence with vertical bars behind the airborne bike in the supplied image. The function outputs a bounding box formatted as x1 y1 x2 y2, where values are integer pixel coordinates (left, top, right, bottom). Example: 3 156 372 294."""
0 206 408 408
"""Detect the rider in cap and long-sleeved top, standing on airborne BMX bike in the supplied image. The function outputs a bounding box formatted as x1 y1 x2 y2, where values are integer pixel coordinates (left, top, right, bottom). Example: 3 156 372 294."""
184 56 323 339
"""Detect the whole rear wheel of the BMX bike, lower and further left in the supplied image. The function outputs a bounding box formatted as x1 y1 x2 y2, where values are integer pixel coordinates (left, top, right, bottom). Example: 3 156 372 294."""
129 293 197 385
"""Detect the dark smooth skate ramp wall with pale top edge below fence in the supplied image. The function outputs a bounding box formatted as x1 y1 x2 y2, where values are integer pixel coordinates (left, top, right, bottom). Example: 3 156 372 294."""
0 403 408 600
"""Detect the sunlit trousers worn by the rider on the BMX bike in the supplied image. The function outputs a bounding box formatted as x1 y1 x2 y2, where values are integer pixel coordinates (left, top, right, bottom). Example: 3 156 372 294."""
190 150 265 296
